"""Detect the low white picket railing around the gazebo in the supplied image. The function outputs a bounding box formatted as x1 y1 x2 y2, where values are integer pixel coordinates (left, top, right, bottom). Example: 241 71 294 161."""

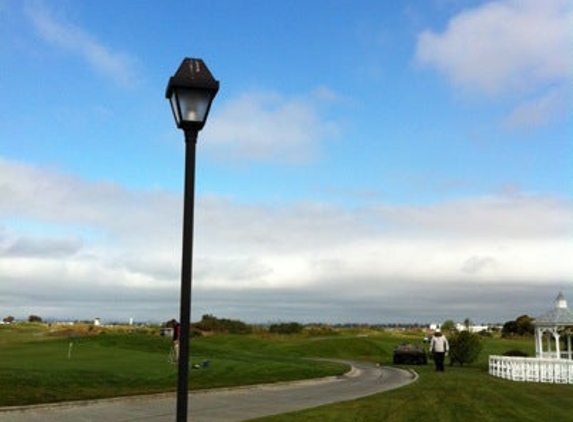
489 356 573 384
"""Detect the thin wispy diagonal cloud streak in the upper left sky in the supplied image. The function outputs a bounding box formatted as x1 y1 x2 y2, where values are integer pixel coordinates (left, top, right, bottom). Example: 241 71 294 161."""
26 3 138 88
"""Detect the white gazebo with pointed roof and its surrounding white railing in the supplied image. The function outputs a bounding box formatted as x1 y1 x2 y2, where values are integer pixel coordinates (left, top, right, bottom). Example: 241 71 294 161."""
489 293 573 384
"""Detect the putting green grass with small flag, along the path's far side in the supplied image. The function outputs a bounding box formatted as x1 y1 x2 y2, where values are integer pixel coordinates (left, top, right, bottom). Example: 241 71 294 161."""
0 324 346 406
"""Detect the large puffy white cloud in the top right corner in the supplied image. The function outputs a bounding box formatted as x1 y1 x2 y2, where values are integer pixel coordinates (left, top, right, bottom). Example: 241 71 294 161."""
416 0 573 96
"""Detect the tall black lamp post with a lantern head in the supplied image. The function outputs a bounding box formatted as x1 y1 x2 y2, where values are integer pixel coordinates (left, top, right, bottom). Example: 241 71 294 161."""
165 58 219 422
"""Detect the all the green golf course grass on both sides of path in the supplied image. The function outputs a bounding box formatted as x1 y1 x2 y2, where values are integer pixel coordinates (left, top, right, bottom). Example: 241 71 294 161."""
0 325 573 422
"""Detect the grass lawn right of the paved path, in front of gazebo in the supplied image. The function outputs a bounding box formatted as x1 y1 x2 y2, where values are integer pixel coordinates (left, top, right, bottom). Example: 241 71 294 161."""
251 336 573 422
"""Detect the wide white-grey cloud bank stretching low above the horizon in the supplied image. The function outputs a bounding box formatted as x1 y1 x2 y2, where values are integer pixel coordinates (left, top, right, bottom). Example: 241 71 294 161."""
0 160 573 322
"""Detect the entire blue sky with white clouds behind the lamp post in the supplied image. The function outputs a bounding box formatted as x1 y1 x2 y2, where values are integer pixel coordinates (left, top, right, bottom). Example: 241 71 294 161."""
0 0 573 324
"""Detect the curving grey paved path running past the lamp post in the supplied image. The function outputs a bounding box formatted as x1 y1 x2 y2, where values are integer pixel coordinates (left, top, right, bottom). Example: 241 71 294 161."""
0 362 417 422
